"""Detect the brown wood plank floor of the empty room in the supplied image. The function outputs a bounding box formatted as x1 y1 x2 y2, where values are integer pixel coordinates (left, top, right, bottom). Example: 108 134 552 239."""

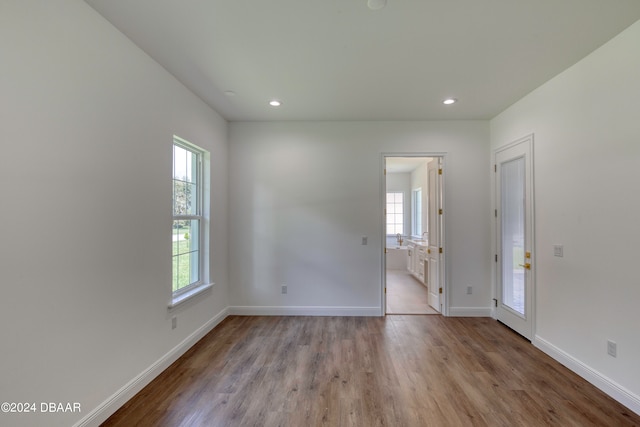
103 316 640 427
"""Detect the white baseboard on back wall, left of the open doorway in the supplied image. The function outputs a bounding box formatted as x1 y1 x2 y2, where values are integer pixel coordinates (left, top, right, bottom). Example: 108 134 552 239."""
229 306 382 317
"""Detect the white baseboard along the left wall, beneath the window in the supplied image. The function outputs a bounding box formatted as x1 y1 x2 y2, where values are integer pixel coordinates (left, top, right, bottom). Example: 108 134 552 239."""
74 308 229 427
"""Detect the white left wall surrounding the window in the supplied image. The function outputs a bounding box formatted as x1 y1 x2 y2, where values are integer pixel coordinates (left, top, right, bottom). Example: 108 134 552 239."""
0 0 228 426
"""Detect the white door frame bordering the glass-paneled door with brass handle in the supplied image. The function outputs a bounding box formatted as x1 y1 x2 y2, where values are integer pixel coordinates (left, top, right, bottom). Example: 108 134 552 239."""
492 134 536 341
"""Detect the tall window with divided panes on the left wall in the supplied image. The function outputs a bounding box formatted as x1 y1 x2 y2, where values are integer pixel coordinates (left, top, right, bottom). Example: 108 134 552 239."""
172 137 208 304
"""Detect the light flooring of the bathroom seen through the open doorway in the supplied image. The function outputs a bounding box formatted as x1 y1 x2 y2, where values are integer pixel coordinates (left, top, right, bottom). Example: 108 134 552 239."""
387 269 438 314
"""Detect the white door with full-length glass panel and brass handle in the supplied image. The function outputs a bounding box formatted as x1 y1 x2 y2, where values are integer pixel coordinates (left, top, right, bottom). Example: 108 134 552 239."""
495 136 535 340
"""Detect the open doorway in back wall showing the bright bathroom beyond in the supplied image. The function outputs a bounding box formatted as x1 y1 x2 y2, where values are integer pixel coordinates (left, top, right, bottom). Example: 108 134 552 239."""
382 153 445 314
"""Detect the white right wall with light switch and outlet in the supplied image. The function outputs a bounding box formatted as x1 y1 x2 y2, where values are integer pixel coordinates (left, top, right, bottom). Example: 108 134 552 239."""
491 22 640 413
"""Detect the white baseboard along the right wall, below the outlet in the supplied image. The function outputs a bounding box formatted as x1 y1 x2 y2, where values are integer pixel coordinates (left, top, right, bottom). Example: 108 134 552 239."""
532 335 640 415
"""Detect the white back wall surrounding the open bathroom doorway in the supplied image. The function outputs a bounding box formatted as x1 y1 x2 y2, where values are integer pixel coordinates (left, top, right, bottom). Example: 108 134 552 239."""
230 121 491 314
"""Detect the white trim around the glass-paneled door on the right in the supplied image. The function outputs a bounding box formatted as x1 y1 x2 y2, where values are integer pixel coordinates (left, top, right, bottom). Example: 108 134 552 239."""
491 133 538 341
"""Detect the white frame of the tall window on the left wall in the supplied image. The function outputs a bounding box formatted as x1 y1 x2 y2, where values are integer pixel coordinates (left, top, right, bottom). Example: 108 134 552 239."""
169 135 213 308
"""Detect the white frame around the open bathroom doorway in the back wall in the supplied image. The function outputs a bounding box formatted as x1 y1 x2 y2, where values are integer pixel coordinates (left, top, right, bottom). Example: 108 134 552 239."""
379 151 449 316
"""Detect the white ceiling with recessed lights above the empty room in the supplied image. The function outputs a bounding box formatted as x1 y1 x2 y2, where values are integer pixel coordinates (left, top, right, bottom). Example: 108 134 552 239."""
86 0 640 121
